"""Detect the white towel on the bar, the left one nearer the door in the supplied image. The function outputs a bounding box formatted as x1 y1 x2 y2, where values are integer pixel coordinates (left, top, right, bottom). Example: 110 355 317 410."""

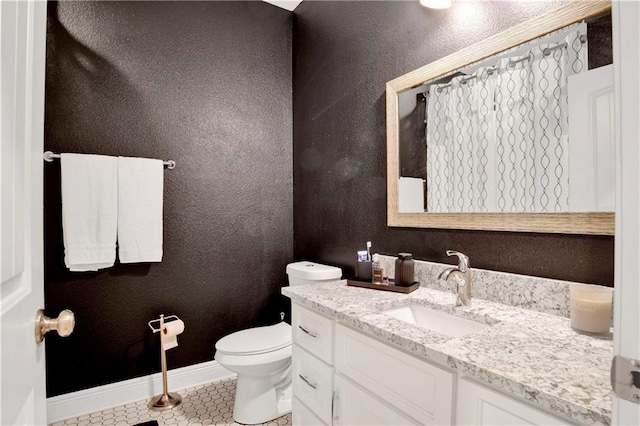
60 154 118 271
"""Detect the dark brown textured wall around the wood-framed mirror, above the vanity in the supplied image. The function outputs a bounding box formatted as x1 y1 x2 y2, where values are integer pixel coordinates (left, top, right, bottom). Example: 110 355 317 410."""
293 0 613 285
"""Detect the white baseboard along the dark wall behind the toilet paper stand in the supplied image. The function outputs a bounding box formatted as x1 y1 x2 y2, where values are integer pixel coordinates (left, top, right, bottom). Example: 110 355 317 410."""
47 361 235 423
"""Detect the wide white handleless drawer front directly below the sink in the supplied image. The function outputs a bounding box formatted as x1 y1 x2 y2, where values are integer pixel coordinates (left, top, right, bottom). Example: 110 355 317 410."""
335 324 454 425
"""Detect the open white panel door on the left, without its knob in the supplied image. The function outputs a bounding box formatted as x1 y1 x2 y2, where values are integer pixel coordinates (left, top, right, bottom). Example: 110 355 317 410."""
0 0 47 425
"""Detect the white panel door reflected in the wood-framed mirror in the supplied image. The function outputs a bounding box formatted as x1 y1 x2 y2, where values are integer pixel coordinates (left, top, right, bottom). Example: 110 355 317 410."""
569 65 616 212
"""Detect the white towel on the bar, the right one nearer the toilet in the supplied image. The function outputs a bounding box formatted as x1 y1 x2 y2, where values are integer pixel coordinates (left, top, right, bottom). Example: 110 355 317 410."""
118 157 164 263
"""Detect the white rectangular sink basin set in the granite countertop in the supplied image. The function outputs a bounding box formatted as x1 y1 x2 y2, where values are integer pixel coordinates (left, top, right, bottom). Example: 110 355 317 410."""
382 305 489 337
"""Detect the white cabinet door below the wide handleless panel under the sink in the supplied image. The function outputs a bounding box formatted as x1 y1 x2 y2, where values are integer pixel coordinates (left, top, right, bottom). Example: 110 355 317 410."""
333 375 420 425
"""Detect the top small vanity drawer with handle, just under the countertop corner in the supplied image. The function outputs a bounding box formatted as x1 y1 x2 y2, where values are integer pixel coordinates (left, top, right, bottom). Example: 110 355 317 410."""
291 305 334 364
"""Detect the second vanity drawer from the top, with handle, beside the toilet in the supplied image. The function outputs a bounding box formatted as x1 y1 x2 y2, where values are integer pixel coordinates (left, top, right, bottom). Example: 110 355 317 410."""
291 344 333 424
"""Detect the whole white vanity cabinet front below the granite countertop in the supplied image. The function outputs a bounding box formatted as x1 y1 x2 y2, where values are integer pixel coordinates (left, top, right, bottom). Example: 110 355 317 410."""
292 303 570 425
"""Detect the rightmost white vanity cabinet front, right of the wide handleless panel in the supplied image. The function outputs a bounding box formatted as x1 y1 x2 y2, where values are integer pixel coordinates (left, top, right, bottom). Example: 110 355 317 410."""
456 379 570 426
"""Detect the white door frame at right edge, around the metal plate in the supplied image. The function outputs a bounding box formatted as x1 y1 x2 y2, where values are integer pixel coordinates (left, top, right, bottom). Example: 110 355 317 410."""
612 1 640 425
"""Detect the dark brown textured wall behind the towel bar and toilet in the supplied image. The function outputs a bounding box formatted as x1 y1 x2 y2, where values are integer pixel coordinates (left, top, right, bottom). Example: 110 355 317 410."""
45 1 293 396
